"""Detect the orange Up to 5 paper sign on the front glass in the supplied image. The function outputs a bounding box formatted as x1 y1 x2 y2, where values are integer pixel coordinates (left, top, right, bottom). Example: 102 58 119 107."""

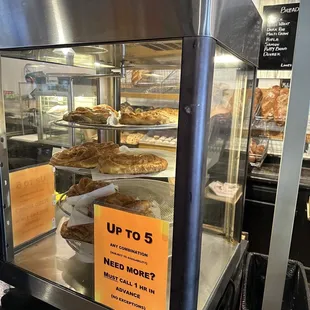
94 205 169 310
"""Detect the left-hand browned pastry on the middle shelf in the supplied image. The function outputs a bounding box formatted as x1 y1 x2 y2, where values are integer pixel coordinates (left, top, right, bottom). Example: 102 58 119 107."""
50 142 119 169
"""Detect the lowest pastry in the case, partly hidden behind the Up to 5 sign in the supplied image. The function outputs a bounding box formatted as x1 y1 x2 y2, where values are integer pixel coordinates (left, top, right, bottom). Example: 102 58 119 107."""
60 221 94 244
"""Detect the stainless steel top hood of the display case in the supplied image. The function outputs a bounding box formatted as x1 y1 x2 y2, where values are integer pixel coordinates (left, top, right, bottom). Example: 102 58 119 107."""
0 0 262 64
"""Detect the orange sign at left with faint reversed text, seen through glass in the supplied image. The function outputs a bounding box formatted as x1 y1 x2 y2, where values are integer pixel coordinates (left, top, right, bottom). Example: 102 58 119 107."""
10 165 55 246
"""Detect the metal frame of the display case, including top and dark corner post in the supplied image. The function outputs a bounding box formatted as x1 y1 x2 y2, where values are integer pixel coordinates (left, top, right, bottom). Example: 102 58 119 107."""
0 0 261 310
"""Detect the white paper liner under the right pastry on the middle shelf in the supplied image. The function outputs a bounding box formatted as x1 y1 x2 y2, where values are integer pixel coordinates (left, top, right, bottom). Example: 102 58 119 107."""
91 146 176 181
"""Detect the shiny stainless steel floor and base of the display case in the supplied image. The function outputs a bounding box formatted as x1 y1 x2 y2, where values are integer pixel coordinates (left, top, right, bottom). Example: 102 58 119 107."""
0 223 245 310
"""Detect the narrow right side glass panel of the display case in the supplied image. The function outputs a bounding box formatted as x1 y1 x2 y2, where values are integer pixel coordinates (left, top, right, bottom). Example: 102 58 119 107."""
198 46 254 309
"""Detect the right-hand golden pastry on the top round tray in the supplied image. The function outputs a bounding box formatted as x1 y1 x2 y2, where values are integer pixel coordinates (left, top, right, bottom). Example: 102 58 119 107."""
119 108 178 125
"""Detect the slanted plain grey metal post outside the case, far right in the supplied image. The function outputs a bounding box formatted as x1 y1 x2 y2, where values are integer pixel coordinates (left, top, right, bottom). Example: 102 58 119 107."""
262 1 310 310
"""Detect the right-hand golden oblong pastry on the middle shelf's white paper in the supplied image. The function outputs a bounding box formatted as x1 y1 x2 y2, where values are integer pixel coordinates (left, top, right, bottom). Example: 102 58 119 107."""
98 153 168 174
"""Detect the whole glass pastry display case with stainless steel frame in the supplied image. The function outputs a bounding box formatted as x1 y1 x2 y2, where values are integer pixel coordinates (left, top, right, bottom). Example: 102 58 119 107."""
0 0 261 310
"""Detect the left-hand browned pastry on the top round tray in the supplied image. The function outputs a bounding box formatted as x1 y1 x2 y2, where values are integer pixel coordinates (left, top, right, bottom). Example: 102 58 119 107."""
63 104 117 124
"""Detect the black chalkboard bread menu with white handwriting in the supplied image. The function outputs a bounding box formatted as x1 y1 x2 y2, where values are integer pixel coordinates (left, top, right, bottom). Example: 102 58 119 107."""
259 3 299 70
